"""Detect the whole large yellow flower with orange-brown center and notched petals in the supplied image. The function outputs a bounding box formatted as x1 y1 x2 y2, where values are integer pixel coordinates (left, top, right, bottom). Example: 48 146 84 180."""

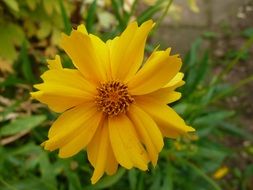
31 20 194 184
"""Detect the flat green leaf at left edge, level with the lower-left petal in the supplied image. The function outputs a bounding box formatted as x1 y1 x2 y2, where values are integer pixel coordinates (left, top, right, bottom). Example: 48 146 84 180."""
0 115 46 136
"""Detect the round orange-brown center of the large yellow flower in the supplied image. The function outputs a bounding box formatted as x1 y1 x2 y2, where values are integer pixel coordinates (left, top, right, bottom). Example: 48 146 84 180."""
95 81 134 116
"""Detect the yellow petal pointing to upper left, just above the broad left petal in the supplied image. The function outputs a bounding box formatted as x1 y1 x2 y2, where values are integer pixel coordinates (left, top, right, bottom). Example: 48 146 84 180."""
61 30 106 84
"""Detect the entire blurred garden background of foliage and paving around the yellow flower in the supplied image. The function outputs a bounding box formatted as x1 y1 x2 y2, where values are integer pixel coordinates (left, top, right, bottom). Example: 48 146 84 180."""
0 0 253 190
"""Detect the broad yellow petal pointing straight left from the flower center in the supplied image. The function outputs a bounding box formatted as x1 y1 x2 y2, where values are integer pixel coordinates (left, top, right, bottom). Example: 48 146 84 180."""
31 69 96 112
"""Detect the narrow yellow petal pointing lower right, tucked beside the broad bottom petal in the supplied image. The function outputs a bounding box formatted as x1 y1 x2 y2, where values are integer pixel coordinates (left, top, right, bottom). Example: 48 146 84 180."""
128 105 163 166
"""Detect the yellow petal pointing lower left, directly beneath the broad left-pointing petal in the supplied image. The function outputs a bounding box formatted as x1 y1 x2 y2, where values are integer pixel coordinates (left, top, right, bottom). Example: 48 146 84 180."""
45 103 99 151
